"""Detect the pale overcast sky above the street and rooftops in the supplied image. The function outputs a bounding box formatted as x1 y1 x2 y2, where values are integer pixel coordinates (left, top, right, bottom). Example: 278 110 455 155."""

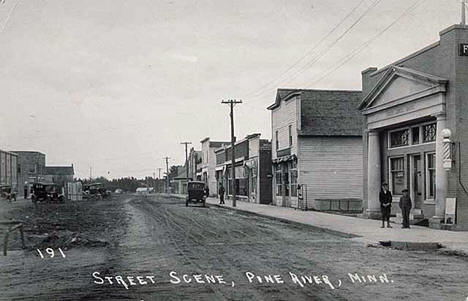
0 0 460 178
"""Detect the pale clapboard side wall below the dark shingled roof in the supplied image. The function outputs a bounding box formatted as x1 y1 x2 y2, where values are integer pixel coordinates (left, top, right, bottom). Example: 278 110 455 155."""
298 137 363 204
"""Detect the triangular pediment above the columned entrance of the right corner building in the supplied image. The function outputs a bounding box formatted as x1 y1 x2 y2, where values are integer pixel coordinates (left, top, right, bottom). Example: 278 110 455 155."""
359 66 448 110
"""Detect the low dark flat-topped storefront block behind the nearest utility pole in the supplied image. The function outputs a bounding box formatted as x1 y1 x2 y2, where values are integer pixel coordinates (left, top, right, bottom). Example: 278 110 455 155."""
215 134 272 204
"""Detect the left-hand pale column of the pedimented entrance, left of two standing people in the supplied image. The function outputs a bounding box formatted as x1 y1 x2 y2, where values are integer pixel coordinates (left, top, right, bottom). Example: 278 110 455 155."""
366 131 382 217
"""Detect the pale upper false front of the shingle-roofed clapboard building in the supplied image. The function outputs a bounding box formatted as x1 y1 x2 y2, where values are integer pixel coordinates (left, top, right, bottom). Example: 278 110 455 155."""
271 97 298 159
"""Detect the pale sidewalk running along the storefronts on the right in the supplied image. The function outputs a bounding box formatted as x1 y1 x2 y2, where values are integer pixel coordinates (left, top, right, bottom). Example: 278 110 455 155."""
207 198 468 255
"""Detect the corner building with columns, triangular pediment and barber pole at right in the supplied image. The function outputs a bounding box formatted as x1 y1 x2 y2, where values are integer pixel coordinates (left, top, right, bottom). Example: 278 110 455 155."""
359 25 468 230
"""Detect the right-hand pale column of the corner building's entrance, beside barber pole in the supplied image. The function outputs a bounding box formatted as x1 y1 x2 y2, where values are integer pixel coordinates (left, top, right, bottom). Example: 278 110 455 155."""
433 114 448 220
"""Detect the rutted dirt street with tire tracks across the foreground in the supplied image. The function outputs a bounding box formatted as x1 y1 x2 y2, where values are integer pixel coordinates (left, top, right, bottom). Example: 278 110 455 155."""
0 195 468 301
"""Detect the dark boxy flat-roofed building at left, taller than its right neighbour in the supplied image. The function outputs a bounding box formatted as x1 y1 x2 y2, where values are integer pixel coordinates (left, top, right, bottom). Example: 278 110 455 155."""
13 151 46 196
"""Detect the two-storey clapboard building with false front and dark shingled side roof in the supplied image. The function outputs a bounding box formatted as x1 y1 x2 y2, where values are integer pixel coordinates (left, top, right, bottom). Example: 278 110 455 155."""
268 89 363 210
